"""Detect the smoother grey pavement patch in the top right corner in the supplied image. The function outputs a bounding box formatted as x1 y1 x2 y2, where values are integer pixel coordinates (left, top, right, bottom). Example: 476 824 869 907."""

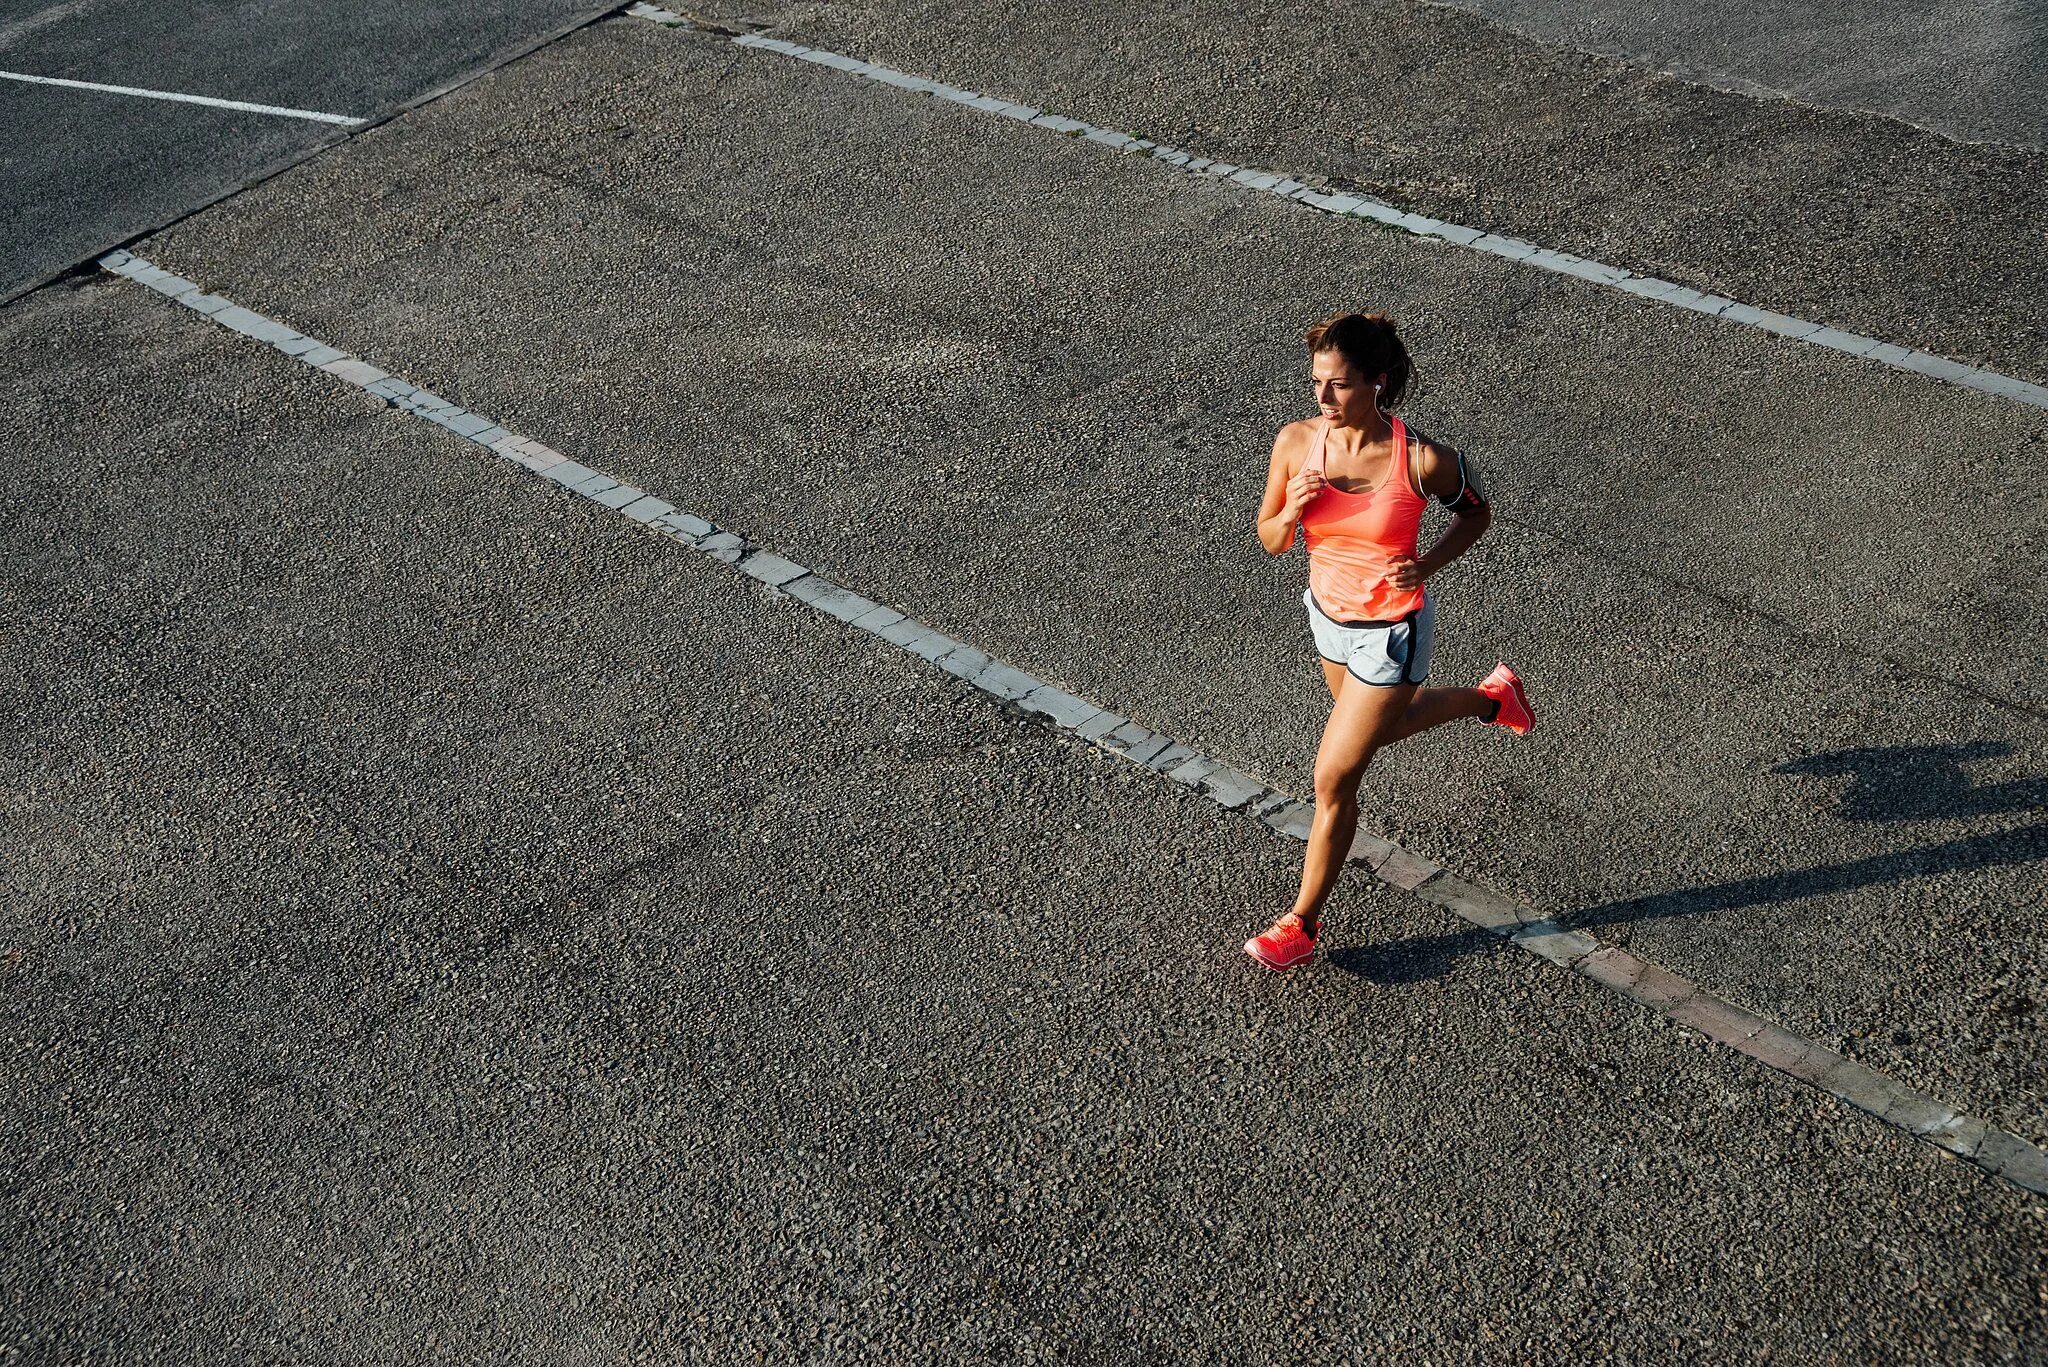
1442 0 2048 150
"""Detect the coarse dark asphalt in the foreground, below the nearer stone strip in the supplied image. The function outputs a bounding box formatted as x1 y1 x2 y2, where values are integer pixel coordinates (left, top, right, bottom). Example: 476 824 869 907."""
0 262 2048 1363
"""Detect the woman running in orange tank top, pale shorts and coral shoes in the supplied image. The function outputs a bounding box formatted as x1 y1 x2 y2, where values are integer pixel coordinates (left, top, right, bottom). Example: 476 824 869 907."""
1245 314 1536 969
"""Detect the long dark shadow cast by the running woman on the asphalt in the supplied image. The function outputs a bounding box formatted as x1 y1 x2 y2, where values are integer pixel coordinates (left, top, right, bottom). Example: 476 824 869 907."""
1329 742 2048 984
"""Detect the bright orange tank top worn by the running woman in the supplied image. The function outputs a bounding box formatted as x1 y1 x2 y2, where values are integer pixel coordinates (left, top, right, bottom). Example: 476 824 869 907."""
1300 418 1427 621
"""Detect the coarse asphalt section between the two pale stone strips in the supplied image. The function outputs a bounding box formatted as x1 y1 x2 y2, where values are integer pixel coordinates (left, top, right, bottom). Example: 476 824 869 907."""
132 23 2048 1142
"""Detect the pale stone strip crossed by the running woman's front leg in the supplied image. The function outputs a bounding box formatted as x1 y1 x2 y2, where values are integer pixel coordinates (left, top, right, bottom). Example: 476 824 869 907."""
98 252 2048 1195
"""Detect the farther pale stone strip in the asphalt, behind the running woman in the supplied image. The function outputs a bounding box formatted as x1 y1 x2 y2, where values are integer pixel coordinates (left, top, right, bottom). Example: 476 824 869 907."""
625 4 2048 408
